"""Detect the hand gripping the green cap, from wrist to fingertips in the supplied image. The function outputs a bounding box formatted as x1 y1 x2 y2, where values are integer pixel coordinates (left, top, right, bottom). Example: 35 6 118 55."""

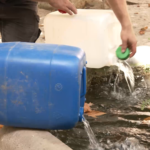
121 26 137 58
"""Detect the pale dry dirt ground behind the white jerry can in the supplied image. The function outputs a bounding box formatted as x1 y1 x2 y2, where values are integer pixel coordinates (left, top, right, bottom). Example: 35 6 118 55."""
37 4 150 46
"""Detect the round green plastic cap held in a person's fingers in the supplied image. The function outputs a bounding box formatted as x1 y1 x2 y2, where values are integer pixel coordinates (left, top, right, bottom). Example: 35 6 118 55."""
116 47 130 60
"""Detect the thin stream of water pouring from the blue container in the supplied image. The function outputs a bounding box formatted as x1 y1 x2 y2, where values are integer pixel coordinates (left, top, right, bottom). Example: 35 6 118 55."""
82 117 103 150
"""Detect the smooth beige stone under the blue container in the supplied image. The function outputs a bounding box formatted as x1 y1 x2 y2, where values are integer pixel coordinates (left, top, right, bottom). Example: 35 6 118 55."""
0 127 71 150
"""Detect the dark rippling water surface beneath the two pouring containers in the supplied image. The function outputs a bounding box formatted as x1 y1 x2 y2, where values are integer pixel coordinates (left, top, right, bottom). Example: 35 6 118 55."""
52 67 150 150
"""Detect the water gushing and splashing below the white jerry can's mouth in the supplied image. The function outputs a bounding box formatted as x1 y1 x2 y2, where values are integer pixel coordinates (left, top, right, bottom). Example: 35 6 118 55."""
109 60 148 103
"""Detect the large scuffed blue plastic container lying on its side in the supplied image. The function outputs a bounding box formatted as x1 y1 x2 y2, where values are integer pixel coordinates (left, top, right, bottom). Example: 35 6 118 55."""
0 42 86 129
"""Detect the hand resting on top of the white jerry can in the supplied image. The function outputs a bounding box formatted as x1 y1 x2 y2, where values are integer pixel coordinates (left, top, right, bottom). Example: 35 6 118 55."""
48 0 77 15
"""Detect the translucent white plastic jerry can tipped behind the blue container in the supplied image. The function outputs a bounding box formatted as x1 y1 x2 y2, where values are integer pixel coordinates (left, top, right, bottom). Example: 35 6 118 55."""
44 9 121 68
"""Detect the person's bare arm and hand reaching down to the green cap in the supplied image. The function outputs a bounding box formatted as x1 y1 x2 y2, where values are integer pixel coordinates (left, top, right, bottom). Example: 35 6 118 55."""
108 0 137 57
